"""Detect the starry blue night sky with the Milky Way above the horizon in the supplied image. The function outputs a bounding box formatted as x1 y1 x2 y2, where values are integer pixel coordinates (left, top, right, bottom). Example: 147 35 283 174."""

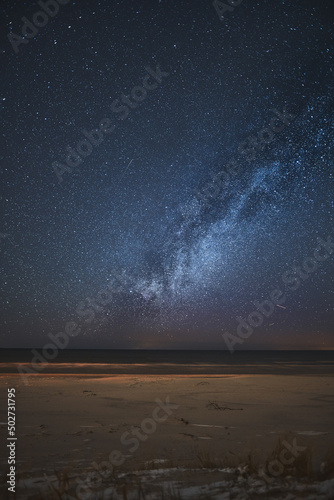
0 0 334 350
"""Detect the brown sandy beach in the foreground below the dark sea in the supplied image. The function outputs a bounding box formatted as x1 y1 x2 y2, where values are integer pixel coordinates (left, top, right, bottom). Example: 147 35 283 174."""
0 374 334 499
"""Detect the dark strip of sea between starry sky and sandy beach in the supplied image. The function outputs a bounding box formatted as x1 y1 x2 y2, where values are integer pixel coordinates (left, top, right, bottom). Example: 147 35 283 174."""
0 349 334 375
